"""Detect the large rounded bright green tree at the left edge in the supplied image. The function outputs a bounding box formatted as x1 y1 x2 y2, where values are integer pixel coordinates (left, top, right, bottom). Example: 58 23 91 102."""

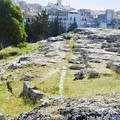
0 0 26 47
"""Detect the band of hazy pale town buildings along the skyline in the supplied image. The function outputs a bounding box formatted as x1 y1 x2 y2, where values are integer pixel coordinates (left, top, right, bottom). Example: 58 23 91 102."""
12 0 120 31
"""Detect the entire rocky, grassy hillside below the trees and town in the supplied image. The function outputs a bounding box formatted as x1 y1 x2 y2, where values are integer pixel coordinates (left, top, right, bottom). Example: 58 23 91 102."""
0 28 120 120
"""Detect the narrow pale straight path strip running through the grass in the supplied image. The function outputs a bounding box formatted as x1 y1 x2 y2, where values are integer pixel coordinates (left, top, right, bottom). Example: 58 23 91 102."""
59 67 67 96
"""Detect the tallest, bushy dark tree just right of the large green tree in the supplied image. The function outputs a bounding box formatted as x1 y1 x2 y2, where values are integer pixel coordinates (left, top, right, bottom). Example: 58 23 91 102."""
31 11 49 40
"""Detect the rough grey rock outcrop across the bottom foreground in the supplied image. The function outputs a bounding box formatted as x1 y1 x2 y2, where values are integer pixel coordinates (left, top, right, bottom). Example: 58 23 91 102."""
16 98 120 120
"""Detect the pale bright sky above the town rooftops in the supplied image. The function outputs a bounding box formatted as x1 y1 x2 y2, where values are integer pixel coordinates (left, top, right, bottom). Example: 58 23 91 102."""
24 0 120 10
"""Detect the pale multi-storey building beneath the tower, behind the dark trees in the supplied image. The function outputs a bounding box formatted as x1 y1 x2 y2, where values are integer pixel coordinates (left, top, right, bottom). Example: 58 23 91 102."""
45 0 74 30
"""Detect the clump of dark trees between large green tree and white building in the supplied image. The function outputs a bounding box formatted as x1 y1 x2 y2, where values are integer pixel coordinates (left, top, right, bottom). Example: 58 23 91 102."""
25 11 65 42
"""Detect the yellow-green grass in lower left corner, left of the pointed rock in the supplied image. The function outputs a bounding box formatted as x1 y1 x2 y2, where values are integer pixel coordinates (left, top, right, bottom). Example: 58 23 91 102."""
0 81 33 117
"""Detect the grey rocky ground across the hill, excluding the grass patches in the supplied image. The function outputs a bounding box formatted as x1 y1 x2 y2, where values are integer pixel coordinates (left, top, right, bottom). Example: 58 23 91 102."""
0 28 120 120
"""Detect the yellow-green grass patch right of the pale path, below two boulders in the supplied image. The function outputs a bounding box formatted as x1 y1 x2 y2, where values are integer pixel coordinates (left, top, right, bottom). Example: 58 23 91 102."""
64 70 120 97
